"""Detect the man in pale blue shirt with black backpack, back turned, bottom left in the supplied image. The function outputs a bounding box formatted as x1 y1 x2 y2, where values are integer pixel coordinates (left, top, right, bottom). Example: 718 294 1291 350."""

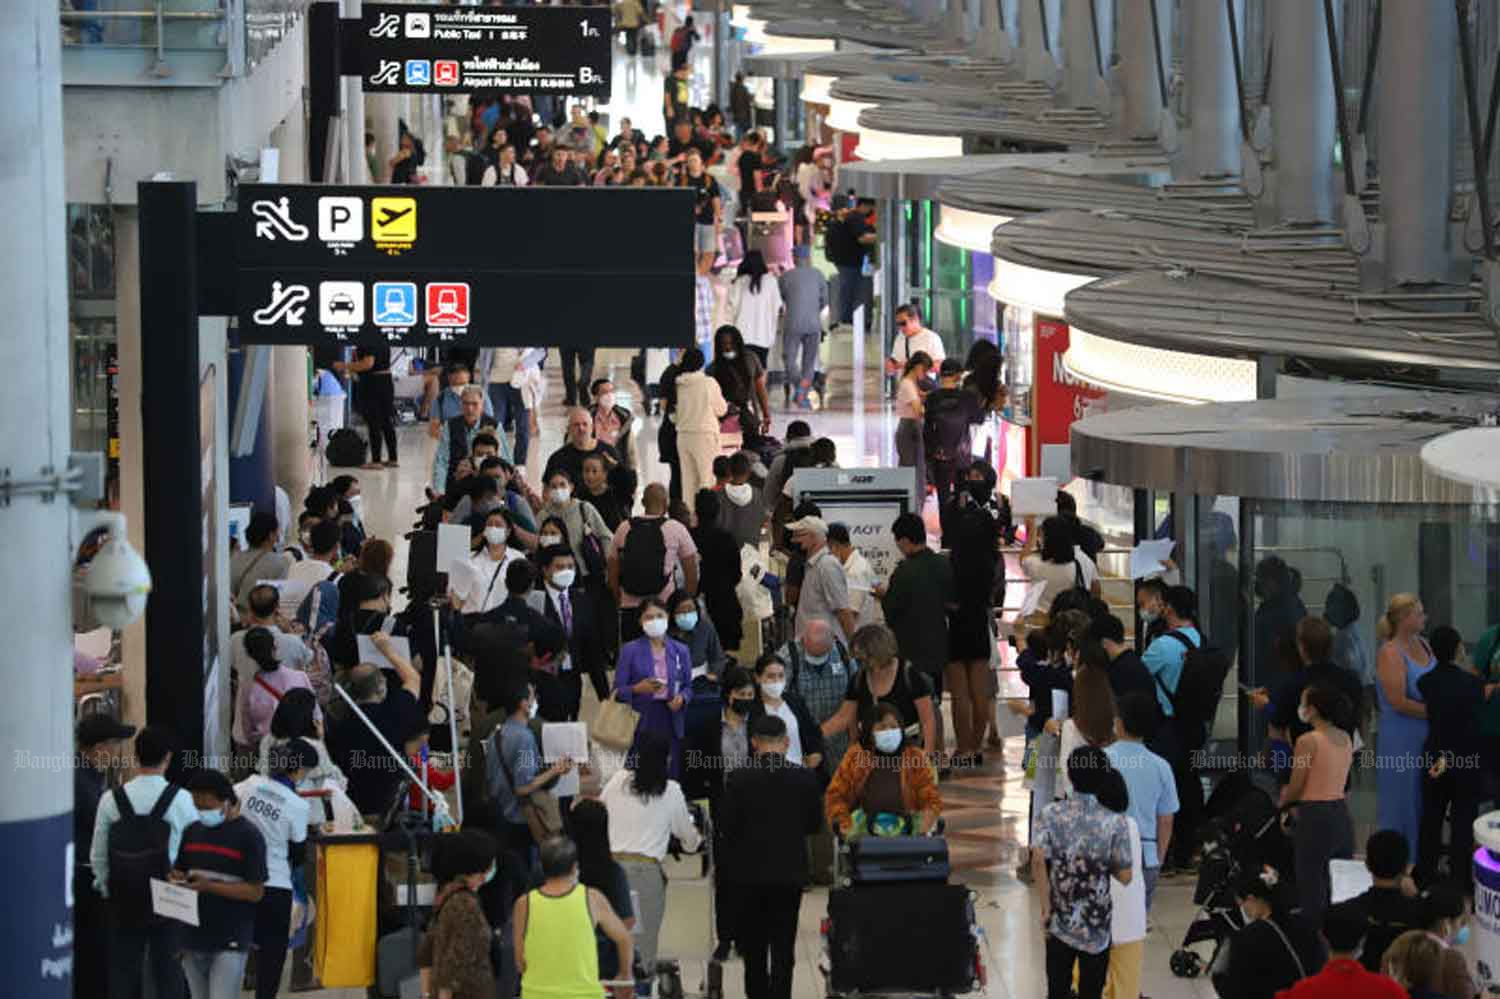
89 726 198 999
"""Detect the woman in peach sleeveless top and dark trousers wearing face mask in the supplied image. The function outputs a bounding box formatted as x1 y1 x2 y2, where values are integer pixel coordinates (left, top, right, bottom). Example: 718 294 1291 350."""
1281 687 1355 926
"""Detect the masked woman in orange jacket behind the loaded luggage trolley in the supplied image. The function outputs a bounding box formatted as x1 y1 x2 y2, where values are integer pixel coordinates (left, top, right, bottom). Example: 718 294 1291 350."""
824 701 942 839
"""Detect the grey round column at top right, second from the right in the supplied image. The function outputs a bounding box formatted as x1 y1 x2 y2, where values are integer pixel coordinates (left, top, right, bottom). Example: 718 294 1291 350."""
1269 0 1338 224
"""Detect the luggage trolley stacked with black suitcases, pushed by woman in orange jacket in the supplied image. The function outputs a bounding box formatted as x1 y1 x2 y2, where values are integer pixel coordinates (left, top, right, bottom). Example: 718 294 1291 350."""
819 827 987 999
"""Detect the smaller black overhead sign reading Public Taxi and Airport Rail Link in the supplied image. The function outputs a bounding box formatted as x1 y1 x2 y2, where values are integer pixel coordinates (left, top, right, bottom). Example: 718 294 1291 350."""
354 3 611 98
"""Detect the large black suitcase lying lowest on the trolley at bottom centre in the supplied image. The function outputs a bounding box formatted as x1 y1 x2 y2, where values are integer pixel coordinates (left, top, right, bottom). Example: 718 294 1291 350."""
828 884 978 995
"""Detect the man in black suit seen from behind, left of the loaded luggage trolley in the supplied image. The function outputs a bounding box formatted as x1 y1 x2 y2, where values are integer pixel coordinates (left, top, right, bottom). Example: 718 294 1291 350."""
720 714 824 999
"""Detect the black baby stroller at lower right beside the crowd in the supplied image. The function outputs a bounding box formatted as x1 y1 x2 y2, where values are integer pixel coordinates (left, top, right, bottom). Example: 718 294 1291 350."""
1172 774 1292 978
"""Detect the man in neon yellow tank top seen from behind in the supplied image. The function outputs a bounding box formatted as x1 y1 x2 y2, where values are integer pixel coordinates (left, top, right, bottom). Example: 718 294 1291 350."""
513 836 635 999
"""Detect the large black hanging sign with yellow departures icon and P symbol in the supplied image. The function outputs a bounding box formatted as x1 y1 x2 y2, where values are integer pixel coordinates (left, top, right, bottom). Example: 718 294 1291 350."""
219 185 695 347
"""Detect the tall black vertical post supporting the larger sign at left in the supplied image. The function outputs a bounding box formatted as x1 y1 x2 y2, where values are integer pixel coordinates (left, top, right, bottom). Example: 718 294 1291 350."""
140 180 212 756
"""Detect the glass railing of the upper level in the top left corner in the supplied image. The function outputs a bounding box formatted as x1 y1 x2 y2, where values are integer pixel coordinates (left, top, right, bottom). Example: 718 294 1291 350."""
60 0 311 84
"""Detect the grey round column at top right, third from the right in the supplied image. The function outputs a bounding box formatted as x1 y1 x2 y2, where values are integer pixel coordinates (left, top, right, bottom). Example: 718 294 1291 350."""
1182 0 1242 177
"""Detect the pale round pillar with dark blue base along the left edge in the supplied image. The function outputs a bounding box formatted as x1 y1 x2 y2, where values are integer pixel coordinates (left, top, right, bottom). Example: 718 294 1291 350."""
0 0 78 999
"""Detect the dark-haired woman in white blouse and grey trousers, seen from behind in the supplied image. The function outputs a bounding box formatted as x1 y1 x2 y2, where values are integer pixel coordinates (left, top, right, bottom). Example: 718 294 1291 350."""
599 732 702 975
